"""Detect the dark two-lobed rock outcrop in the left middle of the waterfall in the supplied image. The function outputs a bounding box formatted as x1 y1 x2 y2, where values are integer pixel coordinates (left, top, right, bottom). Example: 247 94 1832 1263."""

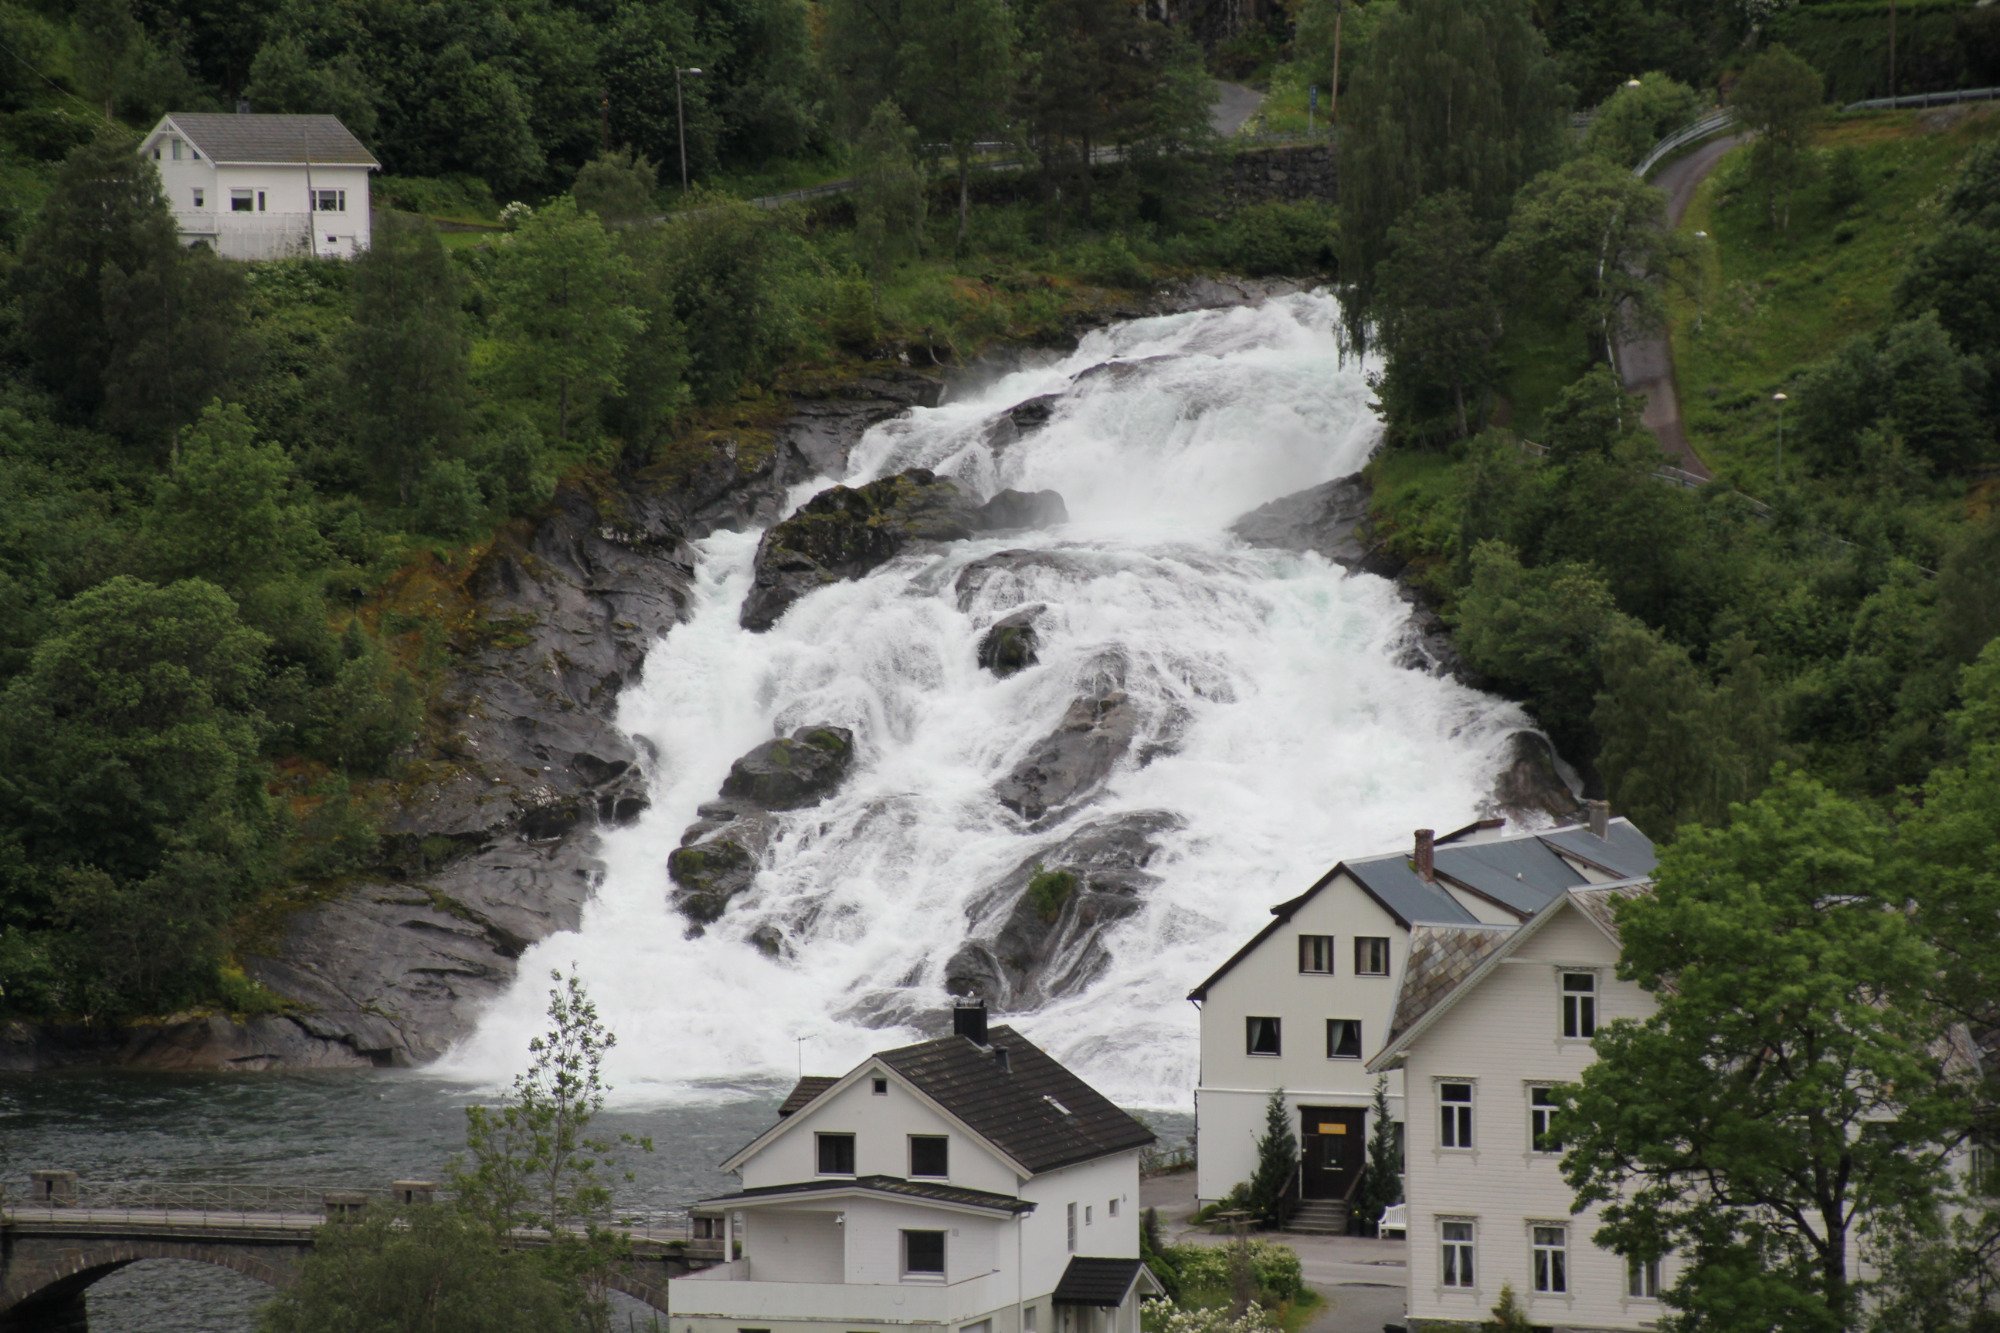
666 727 854 924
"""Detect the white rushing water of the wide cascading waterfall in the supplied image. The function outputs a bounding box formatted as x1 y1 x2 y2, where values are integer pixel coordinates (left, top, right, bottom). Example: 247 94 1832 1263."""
442 294 1526 1107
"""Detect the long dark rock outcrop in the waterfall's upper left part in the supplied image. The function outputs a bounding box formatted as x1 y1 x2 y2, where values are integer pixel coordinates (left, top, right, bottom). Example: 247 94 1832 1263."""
738 468 1068 630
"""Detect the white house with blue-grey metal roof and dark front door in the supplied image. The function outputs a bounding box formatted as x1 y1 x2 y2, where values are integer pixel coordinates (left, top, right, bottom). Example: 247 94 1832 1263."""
1188 803 1654 1231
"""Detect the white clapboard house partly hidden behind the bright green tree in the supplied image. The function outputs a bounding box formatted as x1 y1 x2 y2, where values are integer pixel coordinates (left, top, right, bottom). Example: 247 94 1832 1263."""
1370 881 1676 1329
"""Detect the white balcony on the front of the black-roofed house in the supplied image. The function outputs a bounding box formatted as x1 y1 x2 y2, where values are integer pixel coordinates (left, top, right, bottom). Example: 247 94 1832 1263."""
668 1259 1014 1325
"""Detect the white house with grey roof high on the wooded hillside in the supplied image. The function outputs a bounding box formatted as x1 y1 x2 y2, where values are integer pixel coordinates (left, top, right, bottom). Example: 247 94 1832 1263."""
140 112 382 260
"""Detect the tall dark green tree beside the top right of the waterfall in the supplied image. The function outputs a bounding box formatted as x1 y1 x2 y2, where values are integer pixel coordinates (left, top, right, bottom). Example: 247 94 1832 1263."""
1340 0 1566 342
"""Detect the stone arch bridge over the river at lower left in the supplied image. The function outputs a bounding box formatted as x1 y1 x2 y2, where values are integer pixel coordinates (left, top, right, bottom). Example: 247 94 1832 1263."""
0 1171 720 1333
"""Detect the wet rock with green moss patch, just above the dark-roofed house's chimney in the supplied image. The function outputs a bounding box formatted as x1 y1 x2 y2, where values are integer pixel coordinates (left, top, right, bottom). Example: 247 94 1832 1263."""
944 811 1180 1009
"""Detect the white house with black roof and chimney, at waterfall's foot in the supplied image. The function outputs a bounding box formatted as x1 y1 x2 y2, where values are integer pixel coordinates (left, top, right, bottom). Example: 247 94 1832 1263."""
668 1003 1160 1333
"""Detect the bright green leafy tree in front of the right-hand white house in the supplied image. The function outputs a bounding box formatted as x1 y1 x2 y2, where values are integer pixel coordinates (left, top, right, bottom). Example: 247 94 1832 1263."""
1558 775 1964 1329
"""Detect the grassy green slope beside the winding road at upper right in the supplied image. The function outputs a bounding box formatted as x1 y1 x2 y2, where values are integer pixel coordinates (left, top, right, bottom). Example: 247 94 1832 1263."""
1670 106 2000 492
